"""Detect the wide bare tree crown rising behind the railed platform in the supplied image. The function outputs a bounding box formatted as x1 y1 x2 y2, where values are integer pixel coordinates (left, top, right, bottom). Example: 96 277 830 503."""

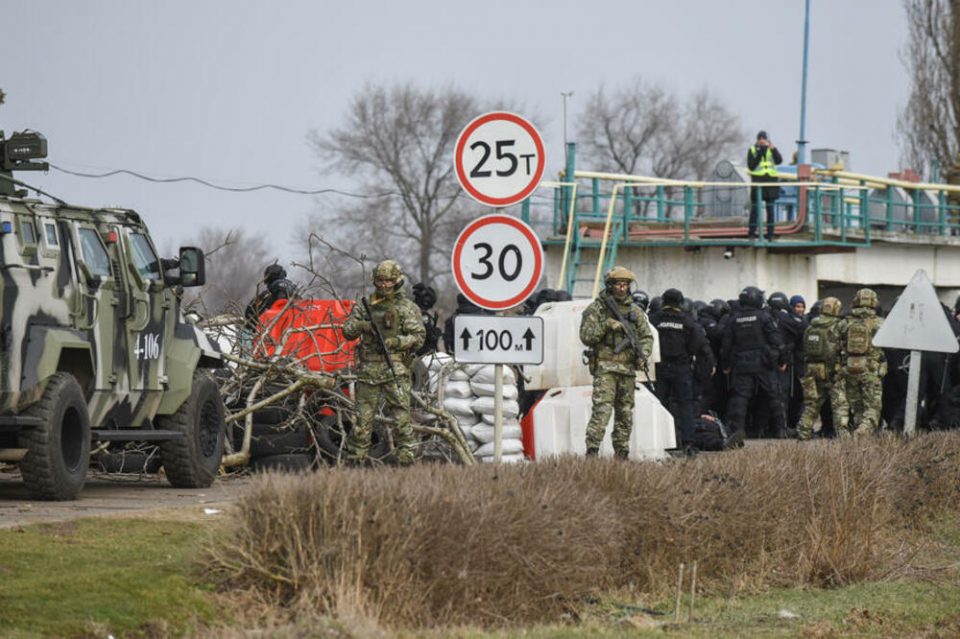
577 78 745 179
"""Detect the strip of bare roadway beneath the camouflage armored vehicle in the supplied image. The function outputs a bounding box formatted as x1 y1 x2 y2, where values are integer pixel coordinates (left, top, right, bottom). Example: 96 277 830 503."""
0 469 250 528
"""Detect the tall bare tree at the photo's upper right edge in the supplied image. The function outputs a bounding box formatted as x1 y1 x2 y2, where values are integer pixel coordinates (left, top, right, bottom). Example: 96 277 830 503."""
897 0 960 184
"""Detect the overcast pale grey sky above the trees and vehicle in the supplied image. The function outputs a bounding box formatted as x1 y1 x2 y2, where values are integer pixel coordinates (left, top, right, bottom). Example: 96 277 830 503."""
0 0 909 261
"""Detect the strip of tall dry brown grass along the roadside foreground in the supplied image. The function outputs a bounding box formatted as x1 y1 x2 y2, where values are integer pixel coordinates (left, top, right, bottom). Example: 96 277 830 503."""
210 433 960 628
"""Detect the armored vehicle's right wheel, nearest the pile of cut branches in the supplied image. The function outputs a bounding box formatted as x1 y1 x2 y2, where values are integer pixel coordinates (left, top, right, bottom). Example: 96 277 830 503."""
157 371 225 488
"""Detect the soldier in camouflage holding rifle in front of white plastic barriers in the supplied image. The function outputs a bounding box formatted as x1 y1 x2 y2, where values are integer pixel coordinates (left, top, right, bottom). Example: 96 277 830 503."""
580 266 653 459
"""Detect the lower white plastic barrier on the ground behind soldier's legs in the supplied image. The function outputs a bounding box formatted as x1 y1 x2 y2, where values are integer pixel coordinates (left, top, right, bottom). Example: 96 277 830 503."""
527 385 676 459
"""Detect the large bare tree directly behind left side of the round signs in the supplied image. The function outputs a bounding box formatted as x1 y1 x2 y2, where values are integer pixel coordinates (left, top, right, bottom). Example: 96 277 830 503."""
308 84 481 283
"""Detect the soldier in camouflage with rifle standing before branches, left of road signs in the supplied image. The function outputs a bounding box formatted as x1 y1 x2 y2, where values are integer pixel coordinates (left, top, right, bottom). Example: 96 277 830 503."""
343 260 426 464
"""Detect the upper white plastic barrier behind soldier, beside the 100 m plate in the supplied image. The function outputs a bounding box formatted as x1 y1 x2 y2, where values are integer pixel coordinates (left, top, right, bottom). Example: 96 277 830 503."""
523 299 660 390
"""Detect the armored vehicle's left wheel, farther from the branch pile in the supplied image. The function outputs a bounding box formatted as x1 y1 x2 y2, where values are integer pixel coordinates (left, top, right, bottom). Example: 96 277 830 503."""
20 373 90 501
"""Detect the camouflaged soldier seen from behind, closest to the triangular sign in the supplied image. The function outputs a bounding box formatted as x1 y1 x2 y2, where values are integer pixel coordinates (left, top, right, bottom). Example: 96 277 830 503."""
840 288 887 435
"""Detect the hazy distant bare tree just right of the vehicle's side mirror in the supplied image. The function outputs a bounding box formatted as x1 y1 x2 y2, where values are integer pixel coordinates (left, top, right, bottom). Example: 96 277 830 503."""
187 226 275 315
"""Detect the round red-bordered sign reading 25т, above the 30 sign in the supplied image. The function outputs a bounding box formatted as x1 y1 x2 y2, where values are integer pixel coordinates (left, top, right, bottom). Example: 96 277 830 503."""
454 111 545 207
